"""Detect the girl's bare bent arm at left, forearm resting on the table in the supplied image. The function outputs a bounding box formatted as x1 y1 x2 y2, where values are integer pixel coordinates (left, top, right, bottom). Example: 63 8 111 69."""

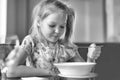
6 48 50 77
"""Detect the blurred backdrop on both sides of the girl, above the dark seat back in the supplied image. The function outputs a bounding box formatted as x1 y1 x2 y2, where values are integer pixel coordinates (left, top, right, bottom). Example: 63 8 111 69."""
0 0 120 43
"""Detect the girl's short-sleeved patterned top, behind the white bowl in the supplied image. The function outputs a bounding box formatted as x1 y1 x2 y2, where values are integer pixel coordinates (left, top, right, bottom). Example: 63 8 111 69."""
21 35 82 79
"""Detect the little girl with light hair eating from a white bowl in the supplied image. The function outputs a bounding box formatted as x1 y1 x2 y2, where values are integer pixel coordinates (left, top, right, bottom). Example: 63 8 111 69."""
6 0 100 80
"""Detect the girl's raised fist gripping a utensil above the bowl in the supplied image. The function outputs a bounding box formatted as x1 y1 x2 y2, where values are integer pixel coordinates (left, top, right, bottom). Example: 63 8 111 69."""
87 43 101 62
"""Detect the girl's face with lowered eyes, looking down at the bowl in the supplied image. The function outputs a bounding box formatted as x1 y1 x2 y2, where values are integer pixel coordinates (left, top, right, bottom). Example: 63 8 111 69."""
40 12 67 42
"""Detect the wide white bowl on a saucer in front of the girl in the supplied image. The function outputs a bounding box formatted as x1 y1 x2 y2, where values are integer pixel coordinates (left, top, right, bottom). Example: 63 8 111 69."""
54 62 96 76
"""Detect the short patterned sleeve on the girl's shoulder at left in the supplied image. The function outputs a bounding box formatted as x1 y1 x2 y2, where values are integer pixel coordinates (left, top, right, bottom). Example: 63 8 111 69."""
20 35 34 54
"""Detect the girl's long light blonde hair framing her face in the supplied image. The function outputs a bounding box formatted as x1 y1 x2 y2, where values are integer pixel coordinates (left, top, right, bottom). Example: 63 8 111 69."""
30 0 75 42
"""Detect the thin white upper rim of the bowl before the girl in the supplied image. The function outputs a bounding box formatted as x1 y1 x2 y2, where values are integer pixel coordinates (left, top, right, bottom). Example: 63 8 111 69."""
54 62 96 66
